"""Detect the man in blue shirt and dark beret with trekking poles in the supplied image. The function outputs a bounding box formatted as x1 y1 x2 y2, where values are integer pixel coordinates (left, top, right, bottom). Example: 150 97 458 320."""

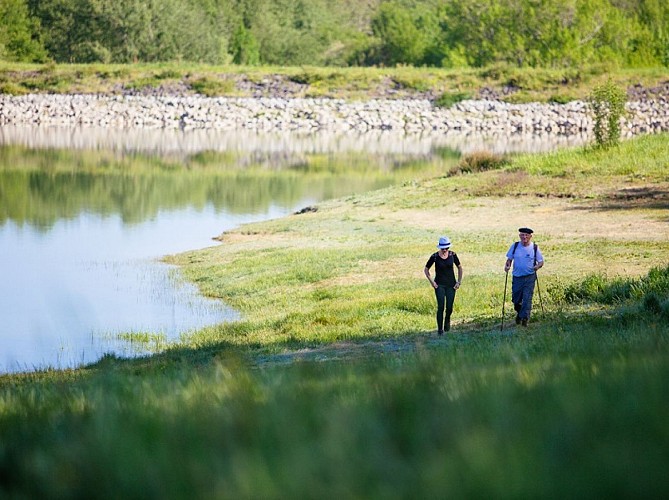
504 227 544 326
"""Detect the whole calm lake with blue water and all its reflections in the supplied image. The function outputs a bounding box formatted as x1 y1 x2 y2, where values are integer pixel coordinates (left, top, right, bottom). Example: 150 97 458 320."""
0 127 585 372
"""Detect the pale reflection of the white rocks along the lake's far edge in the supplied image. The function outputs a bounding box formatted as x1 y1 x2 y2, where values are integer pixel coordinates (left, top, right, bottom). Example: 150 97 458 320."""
0 126 591 156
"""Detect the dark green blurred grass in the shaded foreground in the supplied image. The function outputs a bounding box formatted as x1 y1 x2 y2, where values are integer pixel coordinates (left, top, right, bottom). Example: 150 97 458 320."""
0 304 669 499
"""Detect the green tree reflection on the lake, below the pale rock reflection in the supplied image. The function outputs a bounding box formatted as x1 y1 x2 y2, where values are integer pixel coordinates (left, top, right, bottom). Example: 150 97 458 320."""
0 146 434 229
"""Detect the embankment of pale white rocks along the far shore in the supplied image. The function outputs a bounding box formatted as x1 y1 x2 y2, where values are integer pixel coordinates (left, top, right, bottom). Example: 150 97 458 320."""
0 93 669 136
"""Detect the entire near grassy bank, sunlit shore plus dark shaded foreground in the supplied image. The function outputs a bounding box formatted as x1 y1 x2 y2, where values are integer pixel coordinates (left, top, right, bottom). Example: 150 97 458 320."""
0 135 669 498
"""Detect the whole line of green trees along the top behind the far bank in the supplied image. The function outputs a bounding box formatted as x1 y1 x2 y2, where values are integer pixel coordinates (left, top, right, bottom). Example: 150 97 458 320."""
0 0 669 68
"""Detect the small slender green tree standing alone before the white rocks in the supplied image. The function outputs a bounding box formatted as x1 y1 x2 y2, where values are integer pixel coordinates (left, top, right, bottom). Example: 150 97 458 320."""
588 80 627 148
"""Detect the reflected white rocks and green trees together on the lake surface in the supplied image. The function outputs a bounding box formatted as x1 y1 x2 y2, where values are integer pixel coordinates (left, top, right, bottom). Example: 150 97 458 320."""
0 121 586 228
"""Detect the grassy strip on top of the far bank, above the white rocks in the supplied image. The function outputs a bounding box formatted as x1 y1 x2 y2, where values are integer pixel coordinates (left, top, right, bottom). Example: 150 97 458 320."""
0 62 668 106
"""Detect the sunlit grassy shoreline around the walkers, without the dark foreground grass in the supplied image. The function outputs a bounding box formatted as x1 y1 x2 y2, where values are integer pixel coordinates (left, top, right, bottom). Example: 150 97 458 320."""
167 136 669 356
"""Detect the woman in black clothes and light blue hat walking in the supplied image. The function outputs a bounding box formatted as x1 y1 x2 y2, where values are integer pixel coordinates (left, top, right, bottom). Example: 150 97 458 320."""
425 236 462 335
